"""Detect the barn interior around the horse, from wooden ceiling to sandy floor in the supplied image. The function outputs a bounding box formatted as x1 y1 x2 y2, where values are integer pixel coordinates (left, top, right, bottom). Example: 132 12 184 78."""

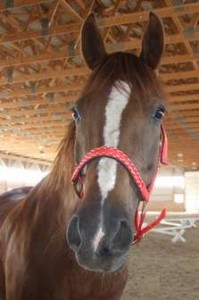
0 0 199 300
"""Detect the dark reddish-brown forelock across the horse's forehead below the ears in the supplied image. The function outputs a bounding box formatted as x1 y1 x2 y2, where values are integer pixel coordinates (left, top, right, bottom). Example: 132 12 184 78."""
82 52 166 101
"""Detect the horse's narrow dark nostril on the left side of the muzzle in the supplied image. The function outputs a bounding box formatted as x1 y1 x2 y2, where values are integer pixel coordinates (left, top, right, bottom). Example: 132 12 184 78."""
67 216 81 251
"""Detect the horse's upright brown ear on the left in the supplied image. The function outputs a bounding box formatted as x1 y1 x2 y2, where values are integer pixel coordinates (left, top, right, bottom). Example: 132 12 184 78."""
81 13 106 70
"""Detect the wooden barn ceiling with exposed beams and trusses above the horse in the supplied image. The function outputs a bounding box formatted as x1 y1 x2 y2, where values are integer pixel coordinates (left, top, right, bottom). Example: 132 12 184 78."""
0 0 199 169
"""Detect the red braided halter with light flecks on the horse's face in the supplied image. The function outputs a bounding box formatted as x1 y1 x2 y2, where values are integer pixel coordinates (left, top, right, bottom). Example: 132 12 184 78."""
71 125 168 243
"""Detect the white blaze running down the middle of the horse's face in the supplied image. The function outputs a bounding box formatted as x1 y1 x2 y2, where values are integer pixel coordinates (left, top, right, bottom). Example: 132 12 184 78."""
93 81 131 250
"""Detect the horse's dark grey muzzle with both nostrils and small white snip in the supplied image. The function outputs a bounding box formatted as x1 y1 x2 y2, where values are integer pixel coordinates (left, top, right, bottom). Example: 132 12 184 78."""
67 215 133 272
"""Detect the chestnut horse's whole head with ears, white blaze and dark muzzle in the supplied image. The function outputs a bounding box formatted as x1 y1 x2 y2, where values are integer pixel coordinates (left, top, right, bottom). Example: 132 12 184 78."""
67 13 165 272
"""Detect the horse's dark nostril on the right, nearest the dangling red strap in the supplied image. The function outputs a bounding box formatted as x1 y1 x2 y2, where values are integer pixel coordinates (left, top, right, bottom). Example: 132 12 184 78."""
112 220 133 253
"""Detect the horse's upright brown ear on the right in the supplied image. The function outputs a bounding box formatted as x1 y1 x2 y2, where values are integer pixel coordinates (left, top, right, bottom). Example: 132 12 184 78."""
140 12 164 69
